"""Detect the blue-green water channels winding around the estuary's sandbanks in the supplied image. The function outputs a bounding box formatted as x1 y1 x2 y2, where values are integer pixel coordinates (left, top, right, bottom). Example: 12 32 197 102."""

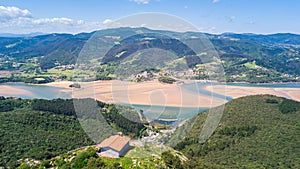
0 82 300 119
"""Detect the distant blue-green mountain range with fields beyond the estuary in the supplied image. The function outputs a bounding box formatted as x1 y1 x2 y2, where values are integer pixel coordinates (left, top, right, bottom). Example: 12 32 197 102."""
0 28 300 83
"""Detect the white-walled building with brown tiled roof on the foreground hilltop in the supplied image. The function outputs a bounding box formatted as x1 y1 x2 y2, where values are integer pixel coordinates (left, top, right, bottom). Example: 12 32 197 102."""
96 134 131 158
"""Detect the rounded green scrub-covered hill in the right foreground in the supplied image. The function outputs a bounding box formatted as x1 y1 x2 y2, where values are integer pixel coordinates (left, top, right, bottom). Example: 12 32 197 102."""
175 95 300 168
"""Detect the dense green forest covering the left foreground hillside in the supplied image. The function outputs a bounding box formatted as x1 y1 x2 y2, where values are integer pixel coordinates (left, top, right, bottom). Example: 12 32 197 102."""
0 97 144 168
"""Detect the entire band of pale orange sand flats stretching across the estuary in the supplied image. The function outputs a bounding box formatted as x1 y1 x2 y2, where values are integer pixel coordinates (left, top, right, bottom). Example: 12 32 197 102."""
0 79 300 108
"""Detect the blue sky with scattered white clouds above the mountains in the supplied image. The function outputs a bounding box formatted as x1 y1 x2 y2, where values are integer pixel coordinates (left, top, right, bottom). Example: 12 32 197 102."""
0 0 300 34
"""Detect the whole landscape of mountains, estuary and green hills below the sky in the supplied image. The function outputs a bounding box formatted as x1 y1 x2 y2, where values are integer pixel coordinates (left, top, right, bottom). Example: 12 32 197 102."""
0 27 300 169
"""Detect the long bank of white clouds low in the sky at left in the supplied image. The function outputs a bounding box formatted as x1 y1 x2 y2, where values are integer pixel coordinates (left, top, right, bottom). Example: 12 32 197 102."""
0 6 103 33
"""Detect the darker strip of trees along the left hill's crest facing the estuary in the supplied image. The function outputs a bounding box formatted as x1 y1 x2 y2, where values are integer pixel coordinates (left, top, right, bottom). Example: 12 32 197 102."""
31 99 144 137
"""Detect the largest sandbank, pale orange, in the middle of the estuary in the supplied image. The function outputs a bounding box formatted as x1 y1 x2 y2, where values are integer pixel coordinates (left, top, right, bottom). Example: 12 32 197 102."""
73 80 225 107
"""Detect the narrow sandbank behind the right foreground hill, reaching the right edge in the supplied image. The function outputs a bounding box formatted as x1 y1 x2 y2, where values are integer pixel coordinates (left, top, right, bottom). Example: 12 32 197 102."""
205 85 300 101
